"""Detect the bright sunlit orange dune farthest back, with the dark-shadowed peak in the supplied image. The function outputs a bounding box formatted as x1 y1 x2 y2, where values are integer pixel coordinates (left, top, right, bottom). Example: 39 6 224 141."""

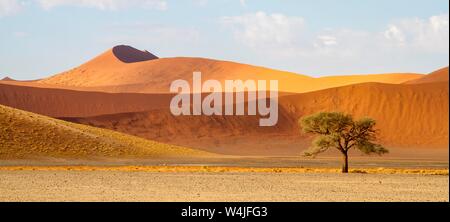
37 46 422 93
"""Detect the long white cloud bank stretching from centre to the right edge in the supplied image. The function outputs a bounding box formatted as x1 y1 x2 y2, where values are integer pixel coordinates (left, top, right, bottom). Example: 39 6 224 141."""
221 12 449 56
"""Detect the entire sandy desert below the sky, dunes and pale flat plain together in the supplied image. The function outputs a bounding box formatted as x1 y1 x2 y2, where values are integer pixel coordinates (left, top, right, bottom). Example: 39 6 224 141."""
0 46 449 202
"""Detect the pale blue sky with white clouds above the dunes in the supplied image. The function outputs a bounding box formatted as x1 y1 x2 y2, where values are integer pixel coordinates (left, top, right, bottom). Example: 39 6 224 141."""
0 0 449 80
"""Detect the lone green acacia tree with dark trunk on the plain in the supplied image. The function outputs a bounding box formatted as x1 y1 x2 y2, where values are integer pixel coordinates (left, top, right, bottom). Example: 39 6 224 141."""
299 112 389 173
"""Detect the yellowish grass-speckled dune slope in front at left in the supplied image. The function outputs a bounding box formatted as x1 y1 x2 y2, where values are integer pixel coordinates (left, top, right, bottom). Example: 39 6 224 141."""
0 105 207 159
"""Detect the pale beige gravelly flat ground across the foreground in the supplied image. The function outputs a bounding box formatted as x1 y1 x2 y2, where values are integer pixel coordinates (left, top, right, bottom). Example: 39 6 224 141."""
0 171 449 202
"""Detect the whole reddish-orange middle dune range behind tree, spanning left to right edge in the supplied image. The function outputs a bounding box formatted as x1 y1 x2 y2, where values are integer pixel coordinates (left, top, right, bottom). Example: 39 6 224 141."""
0 82 449 156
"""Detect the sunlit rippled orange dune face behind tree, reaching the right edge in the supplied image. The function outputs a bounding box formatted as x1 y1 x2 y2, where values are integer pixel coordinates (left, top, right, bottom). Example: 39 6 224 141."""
280 82 449 148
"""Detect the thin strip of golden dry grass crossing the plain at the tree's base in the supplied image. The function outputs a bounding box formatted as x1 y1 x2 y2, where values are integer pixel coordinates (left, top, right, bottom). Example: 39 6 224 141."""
0 166 449 176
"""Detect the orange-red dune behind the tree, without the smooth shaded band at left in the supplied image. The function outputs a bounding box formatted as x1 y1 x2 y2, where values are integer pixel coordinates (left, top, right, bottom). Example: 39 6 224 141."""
60 80 449 155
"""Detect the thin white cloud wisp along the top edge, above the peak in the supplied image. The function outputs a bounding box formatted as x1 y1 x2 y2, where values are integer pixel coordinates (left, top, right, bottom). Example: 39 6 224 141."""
37 0 167 10
